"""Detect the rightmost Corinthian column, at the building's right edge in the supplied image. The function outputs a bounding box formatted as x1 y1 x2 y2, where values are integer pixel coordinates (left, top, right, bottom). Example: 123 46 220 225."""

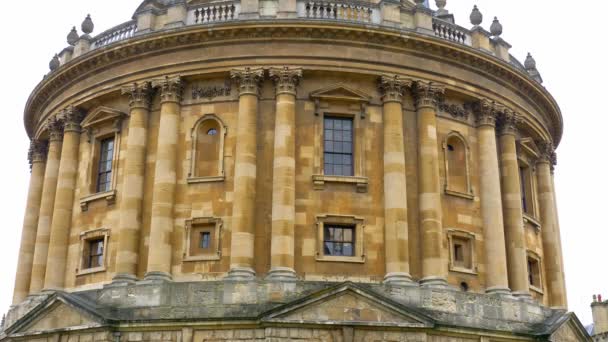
536 142 568 309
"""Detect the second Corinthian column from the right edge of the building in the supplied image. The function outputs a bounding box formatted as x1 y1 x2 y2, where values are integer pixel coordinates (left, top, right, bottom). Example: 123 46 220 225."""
499 110 530 297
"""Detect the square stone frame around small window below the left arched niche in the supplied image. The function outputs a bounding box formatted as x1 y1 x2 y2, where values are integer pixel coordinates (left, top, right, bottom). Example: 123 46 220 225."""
183 217 223 262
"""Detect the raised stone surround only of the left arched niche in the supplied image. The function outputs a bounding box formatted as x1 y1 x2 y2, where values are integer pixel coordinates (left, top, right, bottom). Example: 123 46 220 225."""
187 114 228 184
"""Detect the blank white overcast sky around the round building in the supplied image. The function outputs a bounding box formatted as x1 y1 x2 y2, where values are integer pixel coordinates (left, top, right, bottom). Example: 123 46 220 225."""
0 0 608 325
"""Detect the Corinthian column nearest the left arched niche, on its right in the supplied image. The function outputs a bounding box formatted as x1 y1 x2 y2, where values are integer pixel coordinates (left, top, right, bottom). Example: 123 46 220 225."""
228 68 264 280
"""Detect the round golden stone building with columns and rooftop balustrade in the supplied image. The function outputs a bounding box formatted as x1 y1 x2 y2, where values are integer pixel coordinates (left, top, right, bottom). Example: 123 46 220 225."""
0 0 589 342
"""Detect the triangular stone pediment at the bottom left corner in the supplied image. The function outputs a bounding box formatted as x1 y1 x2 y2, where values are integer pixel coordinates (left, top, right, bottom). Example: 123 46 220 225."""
6 293 106 335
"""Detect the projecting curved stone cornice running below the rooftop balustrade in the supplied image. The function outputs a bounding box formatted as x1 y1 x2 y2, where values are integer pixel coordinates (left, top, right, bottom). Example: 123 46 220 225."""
24 20 563 145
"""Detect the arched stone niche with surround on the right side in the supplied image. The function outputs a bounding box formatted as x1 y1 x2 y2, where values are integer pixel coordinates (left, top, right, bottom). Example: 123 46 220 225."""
443 132 473 198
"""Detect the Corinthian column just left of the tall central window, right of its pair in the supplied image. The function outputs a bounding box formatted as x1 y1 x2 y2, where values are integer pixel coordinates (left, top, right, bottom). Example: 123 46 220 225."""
268 67 302 281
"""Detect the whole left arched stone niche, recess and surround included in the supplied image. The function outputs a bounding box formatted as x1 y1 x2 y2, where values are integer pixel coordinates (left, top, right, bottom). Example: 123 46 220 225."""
189 114 226 183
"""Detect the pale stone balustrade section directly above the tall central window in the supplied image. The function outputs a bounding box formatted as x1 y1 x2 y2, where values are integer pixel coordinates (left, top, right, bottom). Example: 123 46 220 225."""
297 1 381 24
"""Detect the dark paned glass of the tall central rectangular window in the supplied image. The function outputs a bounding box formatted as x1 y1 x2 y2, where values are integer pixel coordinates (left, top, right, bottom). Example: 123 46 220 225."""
323 117 353 176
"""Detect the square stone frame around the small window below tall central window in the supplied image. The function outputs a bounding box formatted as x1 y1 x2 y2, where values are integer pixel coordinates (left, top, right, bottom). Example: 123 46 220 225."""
315 214 366 264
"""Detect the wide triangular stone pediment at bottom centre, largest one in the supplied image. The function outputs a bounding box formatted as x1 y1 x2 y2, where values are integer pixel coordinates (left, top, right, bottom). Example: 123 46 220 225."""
263 283 433 327
